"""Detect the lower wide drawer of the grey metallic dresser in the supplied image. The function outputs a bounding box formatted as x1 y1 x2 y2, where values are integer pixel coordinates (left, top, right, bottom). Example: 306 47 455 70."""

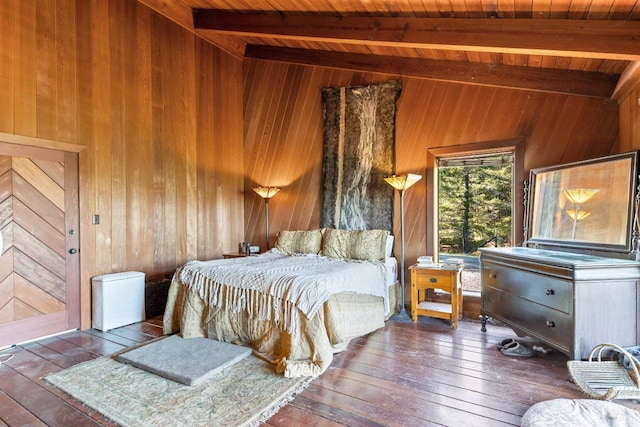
482 290 573 351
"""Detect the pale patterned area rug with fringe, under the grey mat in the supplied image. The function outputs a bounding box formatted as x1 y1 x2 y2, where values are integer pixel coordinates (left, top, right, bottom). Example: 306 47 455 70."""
45 355 312 427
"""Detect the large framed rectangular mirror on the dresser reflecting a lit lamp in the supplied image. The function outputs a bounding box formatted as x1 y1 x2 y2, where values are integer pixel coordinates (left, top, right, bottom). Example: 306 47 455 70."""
525 152 637 253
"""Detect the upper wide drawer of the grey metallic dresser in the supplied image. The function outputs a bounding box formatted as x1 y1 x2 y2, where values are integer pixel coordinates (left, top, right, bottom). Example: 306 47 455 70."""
482 262 573 313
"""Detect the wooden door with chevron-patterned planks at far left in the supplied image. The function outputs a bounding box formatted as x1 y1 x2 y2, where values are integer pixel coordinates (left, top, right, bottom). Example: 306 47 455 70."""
0 143 80 347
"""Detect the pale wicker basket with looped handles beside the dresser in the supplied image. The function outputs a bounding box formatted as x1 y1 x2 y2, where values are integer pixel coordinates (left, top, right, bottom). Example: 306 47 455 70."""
567 344 640 400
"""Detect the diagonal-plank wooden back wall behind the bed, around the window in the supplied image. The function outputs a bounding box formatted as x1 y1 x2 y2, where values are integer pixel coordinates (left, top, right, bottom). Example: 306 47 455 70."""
244 60 619 274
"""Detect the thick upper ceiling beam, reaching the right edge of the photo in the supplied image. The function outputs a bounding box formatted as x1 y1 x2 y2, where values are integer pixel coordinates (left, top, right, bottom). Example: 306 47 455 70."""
193 9 640 61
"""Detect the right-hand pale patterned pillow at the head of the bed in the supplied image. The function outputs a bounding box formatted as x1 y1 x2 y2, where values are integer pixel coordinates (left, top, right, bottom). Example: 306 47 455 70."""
323 228 389 261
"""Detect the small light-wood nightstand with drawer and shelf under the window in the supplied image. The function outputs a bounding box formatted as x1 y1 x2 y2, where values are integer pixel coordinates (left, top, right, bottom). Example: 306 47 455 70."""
409 264 462 329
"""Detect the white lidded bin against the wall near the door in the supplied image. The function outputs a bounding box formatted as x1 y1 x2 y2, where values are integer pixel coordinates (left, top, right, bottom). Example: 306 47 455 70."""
91 271 145 332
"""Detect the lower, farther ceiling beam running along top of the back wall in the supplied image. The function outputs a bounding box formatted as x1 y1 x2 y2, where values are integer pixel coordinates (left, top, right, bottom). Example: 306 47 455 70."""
245 44 617 99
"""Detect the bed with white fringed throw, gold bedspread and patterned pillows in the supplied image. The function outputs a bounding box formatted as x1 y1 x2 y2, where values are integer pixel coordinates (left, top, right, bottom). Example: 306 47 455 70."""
164 229 398 377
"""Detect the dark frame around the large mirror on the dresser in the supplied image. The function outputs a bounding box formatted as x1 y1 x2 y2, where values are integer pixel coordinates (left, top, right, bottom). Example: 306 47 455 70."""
523 151 640 256
